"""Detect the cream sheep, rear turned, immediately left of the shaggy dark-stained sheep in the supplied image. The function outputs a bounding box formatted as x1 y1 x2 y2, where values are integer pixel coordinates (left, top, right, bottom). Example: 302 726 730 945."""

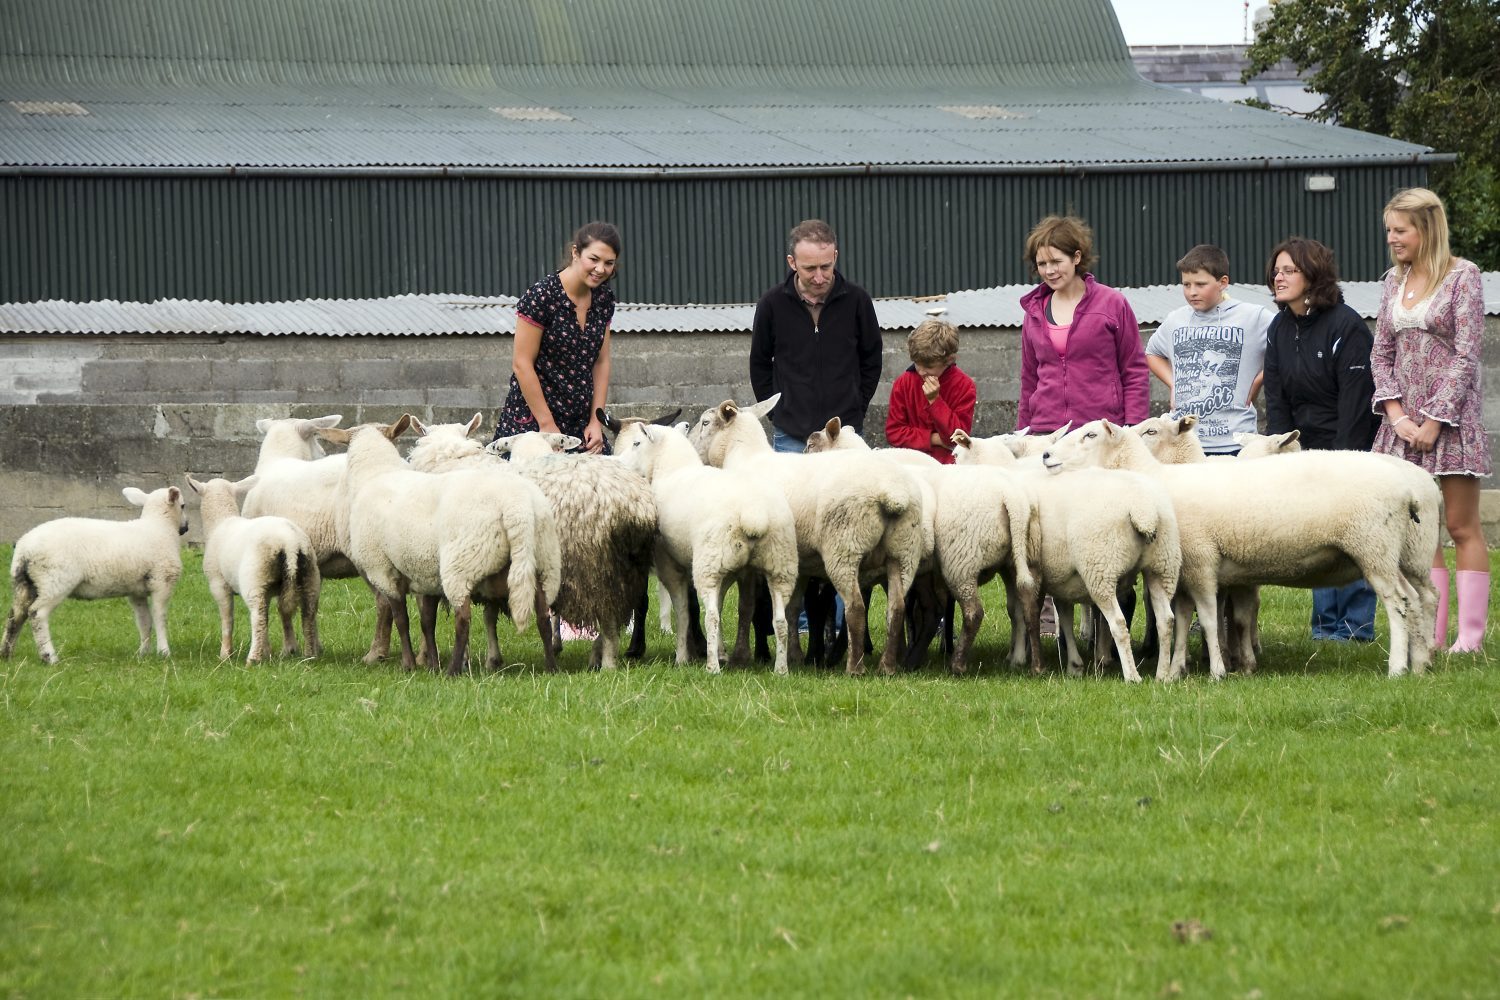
323 414 561 675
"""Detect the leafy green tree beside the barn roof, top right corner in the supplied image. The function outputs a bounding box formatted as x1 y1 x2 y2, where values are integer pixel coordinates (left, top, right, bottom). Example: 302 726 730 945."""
1245 0 1500 270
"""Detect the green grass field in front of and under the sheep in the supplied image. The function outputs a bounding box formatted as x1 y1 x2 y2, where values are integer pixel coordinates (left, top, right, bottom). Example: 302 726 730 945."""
0 550 1500 1000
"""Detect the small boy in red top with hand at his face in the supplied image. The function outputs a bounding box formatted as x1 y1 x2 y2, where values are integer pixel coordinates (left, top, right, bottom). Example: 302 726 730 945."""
885 319 978 465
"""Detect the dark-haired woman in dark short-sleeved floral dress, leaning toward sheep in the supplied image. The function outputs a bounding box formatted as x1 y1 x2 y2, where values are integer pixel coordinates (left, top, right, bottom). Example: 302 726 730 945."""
495 222 620 454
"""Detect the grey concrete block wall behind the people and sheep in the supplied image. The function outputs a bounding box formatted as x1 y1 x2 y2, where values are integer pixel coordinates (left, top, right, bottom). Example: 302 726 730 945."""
0 318 1500 544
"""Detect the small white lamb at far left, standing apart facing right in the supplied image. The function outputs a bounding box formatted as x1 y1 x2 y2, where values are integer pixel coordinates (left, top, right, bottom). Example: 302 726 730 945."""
0 486 188 663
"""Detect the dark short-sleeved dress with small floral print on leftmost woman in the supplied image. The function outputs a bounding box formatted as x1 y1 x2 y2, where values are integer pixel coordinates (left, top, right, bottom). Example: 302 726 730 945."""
495 273 615 453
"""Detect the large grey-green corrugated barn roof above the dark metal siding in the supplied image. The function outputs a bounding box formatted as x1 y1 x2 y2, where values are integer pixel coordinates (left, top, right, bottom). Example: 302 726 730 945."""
0 0 1427 171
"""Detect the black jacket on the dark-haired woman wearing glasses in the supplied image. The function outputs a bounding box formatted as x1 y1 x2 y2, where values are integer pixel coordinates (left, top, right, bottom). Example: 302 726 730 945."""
1266 298 1380 451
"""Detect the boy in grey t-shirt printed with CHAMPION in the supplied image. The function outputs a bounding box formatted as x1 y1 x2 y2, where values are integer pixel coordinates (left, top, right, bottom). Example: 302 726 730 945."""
1146 243 1277 454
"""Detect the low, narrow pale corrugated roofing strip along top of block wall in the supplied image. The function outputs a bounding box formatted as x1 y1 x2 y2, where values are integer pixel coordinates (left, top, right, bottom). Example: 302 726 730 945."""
0 271 1500 337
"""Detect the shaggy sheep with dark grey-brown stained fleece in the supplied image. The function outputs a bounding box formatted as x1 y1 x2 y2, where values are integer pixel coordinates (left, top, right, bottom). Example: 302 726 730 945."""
411 414 656 670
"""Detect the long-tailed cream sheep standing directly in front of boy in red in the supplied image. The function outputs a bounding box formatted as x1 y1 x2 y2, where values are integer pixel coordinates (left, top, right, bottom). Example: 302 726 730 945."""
807 417 1041 675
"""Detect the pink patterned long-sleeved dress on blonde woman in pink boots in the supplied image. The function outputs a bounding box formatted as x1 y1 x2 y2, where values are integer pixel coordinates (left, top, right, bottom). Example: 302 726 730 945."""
1370 259 1491 475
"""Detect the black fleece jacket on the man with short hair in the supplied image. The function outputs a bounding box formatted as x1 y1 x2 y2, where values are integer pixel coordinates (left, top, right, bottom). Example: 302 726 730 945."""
750 271 881 439
